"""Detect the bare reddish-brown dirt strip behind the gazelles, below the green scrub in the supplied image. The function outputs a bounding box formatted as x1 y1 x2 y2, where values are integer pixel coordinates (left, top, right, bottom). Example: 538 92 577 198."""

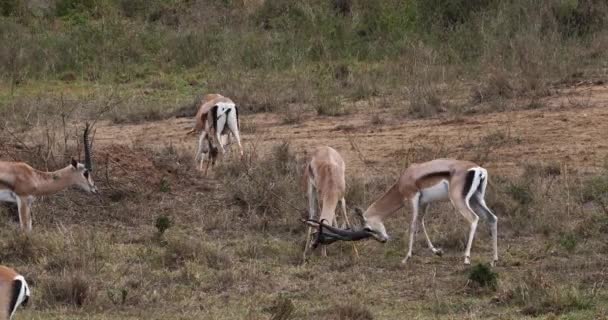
96 85 608 176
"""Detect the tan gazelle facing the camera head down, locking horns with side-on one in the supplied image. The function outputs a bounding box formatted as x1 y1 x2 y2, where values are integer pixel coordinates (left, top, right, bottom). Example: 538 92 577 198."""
303 146 358 260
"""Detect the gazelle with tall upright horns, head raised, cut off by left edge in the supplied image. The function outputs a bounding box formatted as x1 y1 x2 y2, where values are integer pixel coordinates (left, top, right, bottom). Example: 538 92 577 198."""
0 124 97 231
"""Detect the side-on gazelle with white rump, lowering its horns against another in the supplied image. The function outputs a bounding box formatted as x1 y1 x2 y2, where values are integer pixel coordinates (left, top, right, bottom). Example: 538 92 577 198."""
306 159 498 265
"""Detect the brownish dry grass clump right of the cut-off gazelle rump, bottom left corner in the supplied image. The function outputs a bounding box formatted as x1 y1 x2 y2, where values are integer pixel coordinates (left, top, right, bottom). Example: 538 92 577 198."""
39 273 94 307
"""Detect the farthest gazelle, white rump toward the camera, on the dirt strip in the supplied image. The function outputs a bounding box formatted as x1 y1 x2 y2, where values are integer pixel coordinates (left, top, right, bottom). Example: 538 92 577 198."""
187 93 243 172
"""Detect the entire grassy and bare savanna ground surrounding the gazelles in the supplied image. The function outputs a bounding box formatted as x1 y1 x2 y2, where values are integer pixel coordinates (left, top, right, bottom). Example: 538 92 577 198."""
0 0 608 320
